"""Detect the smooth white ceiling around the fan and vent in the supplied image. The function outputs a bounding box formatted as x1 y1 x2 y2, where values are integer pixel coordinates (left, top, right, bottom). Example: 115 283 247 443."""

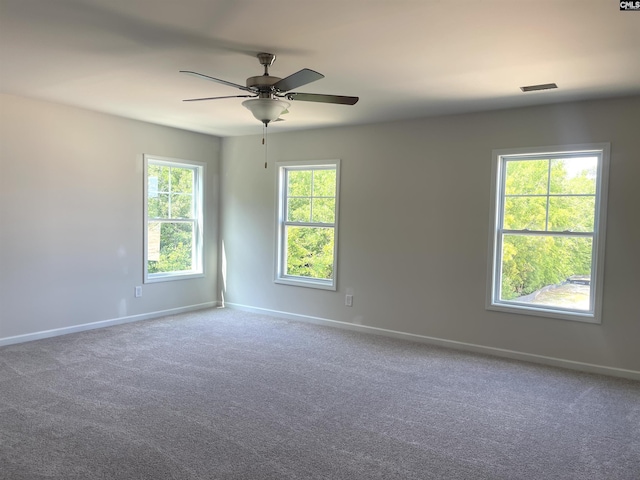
0 0 640 136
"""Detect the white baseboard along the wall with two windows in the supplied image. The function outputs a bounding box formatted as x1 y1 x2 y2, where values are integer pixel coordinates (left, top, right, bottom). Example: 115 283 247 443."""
224 302 640 380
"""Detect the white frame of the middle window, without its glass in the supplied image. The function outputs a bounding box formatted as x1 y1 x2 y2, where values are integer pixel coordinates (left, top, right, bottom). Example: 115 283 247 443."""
274 159 340 291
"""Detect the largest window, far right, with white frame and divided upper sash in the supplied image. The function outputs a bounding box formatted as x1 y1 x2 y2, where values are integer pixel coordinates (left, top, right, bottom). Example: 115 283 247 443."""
487 144 609 323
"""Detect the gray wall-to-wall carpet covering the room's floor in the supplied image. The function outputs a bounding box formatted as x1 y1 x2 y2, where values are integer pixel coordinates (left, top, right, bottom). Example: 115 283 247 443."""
0 309 640 480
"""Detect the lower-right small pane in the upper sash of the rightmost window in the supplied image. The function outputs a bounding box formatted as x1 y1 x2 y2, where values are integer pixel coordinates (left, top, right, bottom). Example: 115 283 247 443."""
549 196 596 232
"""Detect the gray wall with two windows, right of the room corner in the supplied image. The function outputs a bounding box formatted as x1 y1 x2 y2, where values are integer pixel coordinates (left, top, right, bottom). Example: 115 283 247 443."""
219 97 640 371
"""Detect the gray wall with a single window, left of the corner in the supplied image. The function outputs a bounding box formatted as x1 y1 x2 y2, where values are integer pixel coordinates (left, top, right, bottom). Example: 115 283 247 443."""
0 95 221 341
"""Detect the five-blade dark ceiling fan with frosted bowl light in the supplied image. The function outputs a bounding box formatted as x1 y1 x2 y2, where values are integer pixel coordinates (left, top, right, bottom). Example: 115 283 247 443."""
180 53 359 126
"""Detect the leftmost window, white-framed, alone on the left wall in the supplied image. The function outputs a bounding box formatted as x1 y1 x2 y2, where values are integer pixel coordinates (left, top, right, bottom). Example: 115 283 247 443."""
144 155 204 283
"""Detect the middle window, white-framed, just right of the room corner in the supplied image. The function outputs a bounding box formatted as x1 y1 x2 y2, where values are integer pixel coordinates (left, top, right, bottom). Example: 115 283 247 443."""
275 160 340 290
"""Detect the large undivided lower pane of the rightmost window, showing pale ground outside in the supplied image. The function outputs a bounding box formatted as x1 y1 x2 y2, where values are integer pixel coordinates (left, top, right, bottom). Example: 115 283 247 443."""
500 235 593 311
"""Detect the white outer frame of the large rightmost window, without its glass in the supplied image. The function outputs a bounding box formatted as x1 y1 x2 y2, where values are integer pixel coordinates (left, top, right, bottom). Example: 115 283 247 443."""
486 143 610 324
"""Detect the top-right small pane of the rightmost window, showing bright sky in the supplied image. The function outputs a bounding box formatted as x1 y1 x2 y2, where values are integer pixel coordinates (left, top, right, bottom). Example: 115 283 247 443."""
550 157 598 195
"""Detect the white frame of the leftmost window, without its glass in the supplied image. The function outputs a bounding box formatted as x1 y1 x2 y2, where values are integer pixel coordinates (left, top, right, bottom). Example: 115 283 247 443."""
143 154 206 283
